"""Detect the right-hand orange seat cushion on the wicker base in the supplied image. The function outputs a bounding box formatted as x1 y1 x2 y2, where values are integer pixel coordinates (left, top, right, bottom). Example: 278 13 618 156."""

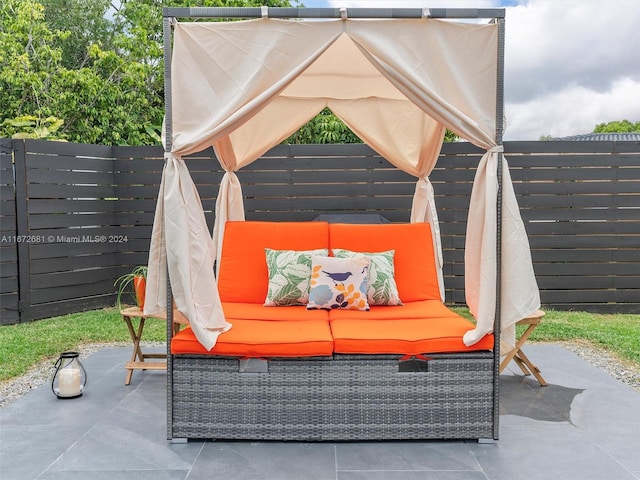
330 302 493 355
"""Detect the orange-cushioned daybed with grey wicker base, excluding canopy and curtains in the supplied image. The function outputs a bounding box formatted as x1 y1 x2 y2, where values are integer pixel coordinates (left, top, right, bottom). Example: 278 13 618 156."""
171 222 493 440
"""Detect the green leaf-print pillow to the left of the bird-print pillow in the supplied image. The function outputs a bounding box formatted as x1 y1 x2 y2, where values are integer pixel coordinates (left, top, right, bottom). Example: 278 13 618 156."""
264 248 329 307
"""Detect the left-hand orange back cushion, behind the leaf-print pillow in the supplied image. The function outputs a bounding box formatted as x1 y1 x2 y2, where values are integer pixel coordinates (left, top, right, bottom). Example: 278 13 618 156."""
218 222 329 304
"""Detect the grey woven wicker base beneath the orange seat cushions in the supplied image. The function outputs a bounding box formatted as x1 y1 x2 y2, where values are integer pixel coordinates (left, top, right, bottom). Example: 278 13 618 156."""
168 352 494 441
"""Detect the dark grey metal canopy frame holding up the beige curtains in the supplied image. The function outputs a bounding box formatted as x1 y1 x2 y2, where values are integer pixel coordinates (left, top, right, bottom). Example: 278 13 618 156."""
163 6 505 440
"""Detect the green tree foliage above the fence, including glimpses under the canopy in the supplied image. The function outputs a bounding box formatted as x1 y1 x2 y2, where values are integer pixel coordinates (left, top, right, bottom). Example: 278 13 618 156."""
0 0 457 145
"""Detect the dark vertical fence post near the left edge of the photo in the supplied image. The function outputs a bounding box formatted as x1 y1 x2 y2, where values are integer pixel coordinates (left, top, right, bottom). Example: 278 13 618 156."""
13 140 32 323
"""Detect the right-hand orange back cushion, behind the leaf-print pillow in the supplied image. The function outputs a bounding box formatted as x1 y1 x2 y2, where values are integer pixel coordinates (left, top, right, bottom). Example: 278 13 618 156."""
329 223 440 303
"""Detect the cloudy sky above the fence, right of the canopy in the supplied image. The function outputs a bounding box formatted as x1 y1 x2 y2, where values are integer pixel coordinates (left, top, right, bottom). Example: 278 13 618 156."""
303 0 640 140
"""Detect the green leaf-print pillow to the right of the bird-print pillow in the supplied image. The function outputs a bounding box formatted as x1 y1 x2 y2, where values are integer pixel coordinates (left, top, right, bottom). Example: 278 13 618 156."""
332 248 402 305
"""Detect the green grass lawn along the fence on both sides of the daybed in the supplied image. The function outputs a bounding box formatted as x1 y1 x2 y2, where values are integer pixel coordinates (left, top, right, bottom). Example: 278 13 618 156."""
0 308 640 380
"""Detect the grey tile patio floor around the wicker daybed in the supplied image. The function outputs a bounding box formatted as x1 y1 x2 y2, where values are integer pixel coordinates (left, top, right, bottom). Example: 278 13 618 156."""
0 344 640 480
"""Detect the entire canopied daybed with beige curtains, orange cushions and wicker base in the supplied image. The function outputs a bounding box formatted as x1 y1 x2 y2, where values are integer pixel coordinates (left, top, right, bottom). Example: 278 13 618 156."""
145 7 540 441
